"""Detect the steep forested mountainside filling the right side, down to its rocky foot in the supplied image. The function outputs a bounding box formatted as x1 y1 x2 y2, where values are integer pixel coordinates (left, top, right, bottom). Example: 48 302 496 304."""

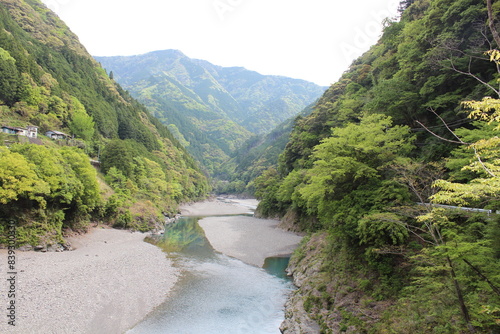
255 0 500 333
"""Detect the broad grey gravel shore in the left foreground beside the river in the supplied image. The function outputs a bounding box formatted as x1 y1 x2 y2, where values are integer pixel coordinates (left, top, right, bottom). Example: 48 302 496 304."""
0 229 178 334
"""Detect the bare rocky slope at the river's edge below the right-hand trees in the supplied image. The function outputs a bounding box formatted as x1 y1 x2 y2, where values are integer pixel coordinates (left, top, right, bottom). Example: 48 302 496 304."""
280 232 391 334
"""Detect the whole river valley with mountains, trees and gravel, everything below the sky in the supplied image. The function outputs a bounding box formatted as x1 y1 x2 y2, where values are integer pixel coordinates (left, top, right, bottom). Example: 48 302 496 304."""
0 0 500 334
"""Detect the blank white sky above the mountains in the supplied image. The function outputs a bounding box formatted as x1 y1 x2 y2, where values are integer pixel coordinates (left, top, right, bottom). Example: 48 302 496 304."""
42 0 399 86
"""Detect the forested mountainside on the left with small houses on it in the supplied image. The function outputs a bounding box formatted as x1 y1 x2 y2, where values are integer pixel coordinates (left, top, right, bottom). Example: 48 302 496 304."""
0 0 209 245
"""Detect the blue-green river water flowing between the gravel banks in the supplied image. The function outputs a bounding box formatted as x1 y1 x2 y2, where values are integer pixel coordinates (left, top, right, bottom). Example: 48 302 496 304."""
127 217 293 334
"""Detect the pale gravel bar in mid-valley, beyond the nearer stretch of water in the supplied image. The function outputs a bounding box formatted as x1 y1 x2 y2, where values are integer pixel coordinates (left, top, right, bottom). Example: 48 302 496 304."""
182 199 302 267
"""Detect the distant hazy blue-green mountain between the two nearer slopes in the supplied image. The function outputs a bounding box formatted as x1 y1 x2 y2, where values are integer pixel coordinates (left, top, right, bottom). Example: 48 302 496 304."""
96 50 324 176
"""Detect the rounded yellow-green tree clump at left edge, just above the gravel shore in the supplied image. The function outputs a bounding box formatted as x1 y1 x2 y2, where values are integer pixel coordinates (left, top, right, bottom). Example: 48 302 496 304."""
0 144 101 244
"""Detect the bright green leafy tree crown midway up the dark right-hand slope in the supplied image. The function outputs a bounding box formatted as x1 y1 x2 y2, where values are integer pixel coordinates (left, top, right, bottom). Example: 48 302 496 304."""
300 114 413 221
